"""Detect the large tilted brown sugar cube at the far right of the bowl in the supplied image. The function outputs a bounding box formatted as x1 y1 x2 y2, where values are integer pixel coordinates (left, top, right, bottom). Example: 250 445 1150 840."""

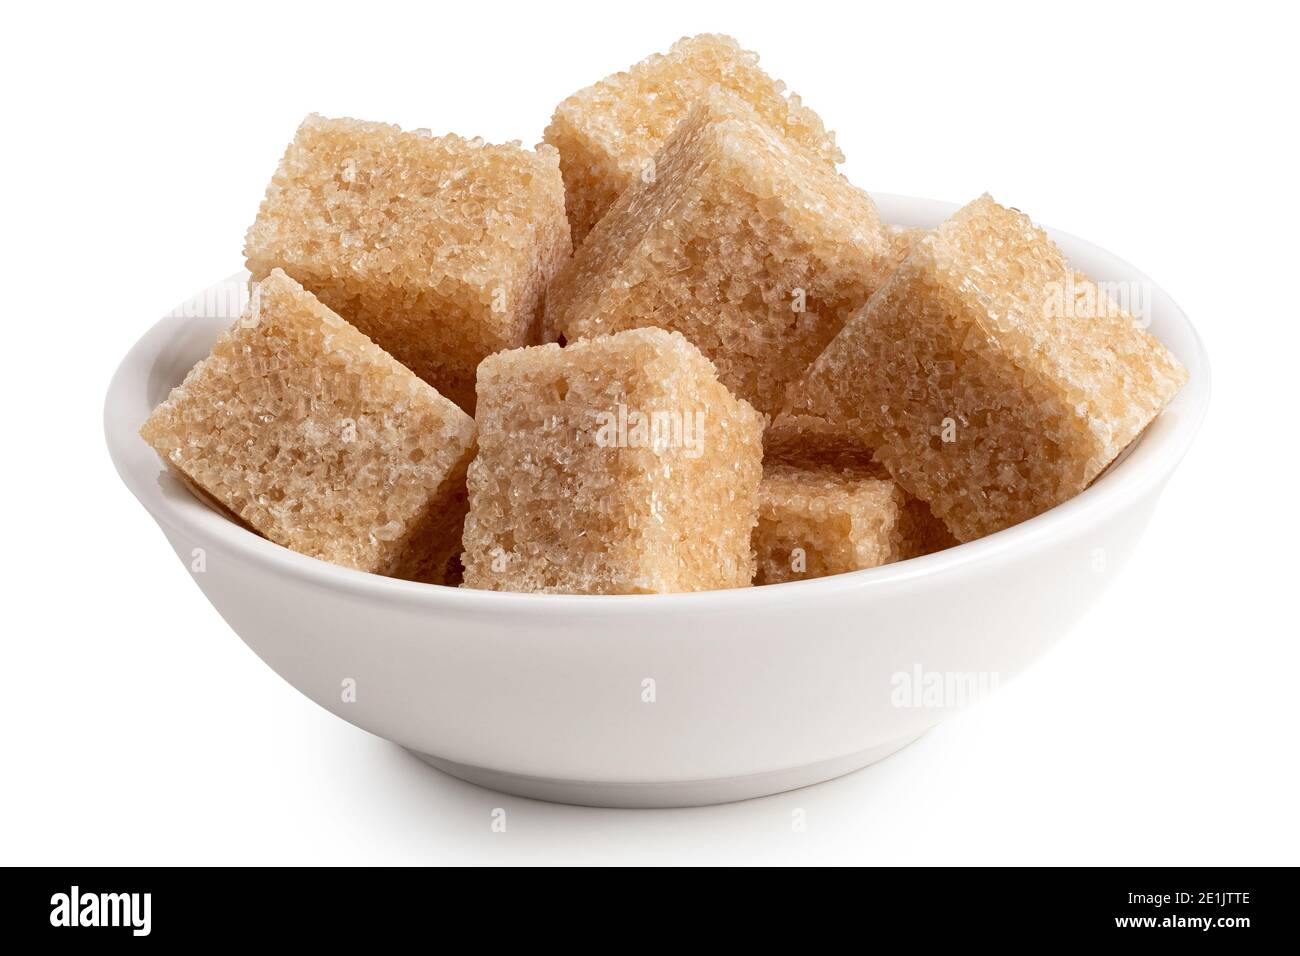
789 195 1187 541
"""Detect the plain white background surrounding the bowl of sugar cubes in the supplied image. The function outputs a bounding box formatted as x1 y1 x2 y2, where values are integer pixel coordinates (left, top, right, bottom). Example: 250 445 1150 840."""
0 0 1300 864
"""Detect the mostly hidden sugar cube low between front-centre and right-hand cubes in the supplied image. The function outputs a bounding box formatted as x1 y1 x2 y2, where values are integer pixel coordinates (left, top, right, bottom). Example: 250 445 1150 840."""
754 460 950 584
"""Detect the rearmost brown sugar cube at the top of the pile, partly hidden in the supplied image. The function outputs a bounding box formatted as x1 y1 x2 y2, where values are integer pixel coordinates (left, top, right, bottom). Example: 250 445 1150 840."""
545 34 844 246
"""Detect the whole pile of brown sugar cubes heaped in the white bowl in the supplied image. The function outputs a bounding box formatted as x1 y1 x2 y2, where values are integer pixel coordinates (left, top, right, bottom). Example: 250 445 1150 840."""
140 34 1187 594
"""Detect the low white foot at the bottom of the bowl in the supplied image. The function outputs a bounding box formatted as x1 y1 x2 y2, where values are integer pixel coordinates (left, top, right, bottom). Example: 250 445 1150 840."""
411 731 924 809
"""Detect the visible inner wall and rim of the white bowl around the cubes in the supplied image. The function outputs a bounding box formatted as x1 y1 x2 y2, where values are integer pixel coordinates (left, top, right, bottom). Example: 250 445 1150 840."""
104 195 1209 610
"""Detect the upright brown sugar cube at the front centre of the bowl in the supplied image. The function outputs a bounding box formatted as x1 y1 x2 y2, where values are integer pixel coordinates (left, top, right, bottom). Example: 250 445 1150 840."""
463 329 763 594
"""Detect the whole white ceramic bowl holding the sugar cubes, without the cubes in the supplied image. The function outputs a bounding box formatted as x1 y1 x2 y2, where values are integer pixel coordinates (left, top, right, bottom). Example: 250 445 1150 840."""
104 196 1209 806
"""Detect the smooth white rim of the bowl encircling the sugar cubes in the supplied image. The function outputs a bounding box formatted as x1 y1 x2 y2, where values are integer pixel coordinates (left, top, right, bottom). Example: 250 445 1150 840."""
104 193 1210 615
